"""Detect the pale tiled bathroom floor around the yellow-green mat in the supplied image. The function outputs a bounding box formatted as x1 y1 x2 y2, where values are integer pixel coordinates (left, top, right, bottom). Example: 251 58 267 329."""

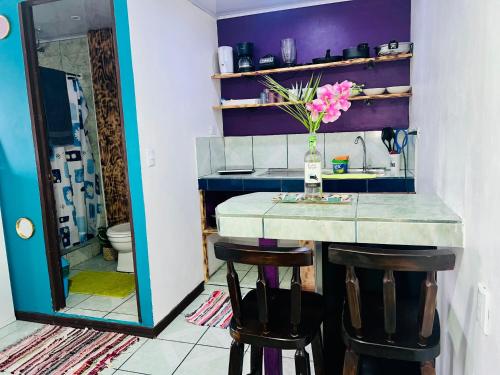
61 255 139 322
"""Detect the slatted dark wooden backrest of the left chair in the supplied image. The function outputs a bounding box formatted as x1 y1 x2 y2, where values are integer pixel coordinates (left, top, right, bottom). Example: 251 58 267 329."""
214 242 313 334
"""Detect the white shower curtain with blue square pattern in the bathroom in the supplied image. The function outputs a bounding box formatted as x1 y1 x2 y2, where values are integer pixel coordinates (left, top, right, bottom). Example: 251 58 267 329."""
50 75 101 249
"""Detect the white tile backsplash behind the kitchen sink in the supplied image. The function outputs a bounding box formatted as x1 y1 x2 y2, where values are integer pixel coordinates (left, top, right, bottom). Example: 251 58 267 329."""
196 131 416 176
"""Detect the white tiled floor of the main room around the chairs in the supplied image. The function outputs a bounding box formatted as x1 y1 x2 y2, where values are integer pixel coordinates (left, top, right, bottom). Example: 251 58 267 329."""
0 266 314 375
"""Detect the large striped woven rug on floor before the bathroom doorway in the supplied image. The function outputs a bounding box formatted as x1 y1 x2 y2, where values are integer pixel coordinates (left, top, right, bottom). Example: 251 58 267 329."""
0 326 139 375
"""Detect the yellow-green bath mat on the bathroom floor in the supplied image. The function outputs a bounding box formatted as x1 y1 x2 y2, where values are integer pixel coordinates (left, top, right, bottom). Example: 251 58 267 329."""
69 271 135 298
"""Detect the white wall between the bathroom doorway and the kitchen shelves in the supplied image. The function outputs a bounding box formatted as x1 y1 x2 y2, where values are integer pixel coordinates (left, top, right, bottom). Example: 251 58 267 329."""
128 0 222 324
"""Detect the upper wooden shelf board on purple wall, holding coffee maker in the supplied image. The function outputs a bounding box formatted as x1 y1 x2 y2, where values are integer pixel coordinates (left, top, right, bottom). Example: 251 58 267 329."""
212 53 413 79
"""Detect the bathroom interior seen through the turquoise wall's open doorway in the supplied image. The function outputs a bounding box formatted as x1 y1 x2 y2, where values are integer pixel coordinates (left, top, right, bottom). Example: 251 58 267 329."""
28 0 140 322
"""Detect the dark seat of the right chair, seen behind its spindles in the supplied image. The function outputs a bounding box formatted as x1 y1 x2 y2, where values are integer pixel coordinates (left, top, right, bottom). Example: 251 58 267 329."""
342 295 440 362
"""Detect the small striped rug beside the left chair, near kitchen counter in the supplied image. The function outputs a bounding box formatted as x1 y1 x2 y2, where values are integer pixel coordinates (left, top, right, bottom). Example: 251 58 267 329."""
186 290 233 328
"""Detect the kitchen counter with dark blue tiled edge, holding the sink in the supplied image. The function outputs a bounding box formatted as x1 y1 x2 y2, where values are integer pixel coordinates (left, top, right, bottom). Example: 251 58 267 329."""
198 169 415 193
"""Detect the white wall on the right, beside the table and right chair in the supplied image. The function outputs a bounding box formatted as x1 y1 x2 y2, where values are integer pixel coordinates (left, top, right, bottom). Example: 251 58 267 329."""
410 0 500 375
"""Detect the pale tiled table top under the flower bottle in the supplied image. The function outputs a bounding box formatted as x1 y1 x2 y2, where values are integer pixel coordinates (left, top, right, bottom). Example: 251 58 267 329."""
216 193 463 246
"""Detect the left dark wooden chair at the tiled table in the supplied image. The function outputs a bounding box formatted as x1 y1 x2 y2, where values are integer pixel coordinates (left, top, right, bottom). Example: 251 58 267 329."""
215 242 325 375
